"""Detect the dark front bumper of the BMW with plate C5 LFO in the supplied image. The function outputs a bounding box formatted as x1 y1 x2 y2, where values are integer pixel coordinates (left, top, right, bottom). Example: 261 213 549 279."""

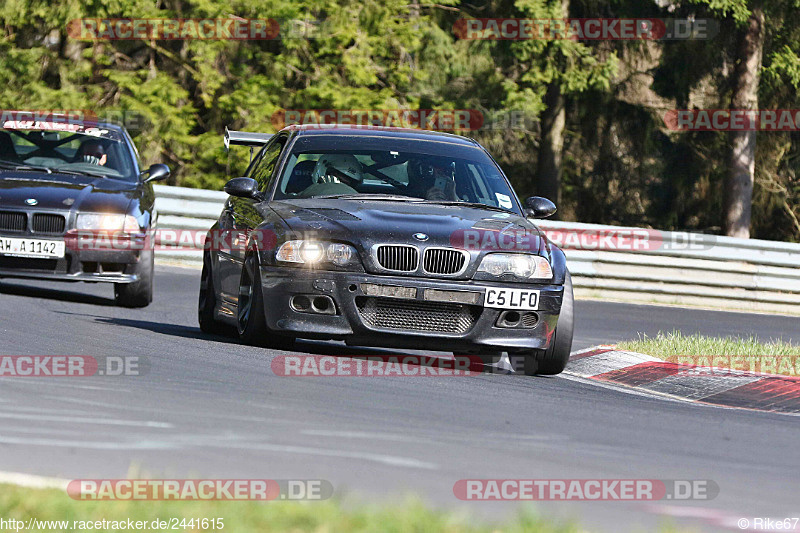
261 266 563 352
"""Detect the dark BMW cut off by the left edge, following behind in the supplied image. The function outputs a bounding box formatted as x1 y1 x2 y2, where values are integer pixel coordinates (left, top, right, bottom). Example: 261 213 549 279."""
0 116 169 307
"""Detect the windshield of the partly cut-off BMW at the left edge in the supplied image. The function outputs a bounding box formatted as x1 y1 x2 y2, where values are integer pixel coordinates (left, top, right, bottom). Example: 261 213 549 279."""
0 122 138 181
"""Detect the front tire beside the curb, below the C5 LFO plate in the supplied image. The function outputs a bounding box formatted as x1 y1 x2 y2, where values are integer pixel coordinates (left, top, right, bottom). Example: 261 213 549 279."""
509 271 575 376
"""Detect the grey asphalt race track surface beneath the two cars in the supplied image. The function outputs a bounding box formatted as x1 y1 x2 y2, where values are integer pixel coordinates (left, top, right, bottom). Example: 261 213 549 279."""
0 267 800 531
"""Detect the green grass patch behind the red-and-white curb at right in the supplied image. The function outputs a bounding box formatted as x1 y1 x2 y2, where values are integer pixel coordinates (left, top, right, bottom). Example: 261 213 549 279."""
617 331 800 376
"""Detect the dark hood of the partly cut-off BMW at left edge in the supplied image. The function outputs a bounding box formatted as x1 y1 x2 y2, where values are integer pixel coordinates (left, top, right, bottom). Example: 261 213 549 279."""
0 171 137 213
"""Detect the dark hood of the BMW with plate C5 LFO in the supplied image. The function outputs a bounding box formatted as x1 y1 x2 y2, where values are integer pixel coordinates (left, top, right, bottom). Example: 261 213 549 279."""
271 199 548 255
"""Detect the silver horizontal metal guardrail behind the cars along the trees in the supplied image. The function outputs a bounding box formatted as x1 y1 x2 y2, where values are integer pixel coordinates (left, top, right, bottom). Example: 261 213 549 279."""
154 185 800 314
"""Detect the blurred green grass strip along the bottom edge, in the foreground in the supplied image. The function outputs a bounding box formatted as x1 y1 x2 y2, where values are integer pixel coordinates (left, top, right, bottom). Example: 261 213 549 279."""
0 485 583 533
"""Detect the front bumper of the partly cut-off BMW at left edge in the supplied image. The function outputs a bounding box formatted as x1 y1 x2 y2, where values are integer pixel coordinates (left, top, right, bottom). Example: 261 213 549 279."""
0 233 141 283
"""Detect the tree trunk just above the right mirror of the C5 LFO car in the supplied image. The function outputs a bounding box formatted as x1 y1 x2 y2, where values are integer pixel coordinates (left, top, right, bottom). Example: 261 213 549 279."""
535 82 566 205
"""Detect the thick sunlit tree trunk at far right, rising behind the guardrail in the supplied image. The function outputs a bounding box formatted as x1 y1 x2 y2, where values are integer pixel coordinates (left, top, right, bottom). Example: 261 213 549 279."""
723 6 764 239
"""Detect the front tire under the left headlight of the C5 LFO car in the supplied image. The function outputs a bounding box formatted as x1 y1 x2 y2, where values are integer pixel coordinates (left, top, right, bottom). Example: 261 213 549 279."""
236 254 294 348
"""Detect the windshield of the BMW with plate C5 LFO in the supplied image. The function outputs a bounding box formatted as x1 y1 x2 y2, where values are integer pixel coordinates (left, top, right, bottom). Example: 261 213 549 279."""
275 135 517 212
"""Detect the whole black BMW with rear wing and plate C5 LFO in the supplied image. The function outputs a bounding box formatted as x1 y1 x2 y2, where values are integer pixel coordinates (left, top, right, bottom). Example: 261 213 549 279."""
199 126 573 374
